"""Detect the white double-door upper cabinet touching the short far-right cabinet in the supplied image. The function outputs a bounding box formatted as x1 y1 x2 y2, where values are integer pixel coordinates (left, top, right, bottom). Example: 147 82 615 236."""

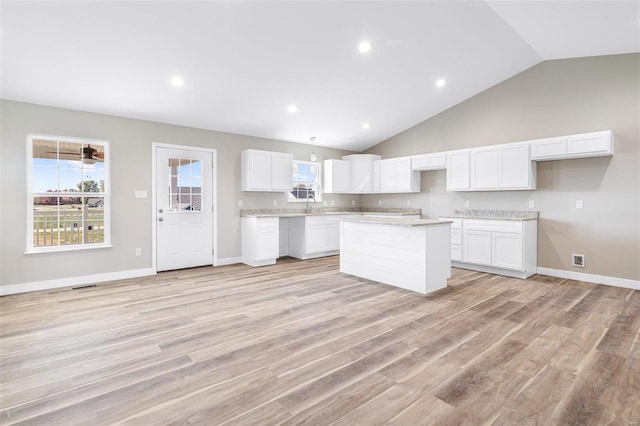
469 142 536 191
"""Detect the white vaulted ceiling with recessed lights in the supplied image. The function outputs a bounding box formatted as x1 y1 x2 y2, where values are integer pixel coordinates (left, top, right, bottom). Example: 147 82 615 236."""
0 0 640 151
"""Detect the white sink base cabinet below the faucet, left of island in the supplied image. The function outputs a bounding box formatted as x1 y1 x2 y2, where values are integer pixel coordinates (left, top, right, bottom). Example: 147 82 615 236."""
289 216 340 260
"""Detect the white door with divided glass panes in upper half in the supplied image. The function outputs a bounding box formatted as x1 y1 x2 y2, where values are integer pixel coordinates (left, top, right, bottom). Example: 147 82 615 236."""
156 146 213 271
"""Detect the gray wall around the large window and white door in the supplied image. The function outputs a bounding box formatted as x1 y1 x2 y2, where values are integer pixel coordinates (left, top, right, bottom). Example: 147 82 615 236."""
0 101 358 285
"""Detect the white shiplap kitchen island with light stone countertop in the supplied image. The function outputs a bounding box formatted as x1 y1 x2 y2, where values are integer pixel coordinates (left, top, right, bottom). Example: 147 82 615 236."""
334 216 451 294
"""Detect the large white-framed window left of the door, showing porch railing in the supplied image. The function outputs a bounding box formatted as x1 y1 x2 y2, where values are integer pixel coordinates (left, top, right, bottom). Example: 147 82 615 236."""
27 135 111 252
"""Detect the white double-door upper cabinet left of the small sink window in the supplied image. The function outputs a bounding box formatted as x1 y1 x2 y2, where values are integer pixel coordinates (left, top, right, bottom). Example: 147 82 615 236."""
241 149 293 192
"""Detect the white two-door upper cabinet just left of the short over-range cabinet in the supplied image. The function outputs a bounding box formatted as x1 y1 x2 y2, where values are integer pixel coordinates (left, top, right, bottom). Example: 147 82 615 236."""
373 157 420 193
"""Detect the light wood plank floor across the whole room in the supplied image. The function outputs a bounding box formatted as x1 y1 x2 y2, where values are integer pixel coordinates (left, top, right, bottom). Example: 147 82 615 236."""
0 257 640 426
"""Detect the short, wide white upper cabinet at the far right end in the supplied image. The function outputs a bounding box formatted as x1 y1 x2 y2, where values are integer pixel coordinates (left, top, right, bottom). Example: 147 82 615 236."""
529 130 614 161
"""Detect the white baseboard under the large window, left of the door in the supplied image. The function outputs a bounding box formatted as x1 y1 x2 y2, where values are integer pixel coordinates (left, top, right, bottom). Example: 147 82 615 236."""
0 268 156 296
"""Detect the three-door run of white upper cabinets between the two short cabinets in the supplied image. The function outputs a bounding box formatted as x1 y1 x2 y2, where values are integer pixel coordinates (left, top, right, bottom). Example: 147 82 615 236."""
447 142 536 191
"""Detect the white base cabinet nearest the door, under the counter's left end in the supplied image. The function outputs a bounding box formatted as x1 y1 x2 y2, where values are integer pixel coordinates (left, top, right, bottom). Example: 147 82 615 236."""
240 217 280 266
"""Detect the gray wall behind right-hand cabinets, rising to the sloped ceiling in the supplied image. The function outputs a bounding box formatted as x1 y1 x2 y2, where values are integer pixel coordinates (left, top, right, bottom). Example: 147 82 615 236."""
361 54 640 280
